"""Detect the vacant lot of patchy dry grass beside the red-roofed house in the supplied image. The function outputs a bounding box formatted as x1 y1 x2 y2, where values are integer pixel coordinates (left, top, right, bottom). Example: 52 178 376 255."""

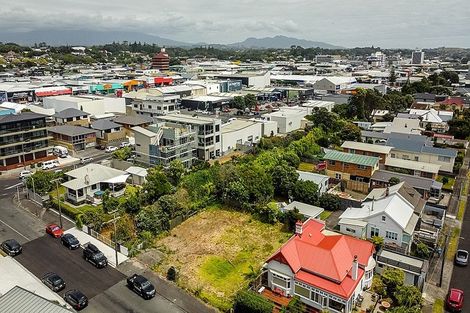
155 208 290 311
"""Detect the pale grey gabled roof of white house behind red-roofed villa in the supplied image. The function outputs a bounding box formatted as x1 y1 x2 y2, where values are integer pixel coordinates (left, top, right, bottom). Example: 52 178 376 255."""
340 193 414 230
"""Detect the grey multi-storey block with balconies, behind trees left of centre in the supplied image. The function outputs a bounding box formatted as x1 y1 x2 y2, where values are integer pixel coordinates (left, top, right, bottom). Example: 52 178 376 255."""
132 122 198 168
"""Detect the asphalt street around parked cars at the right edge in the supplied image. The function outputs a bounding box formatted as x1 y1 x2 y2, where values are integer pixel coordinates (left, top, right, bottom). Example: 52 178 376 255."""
450 191 470 312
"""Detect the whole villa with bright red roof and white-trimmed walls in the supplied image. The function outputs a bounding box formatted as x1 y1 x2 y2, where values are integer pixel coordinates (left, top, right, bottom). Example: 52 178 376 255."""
265 219 376 313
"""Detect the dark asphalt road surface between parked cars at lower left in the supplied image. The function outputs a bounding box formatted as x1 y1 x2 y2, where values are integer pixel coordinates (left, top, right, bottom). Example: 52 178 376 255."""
15 235 124 299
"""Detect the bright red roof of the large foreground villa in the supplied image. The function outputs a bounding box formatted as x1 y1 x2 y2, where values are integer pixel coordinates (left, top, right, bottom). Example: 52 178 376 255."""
269 219 374 299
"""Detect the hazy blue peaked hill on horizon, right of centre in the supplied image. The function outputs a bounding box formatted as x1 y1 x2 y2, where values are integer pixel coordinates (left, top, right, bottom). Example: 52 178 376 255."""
228 36 343 49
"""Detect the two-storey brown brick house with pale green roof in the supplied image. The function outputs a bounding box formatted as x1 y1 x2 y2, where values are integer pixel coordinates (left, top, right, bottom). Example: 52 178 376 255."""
323 150 380 193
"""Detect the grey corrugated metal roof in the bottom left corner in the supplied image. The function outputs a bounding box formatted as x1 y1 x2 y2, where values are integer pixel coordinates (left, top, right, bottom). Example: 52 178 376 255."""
0 286 72 313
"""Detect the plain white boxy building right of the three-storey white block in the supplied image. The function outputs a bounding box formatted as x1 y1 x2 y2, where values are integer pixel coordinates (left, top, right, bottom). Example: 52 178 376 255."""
222 119 263 154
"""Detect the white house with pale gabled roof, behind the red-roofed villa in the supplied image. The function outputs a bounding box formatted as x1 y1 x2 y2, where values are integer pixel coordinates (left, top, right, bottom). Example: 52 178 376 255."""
339 185 419 252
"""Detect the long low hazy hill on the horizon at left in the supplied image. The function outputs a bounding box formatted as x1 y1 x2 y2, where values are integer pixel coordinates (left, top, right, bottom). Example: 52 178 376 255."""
0 30 192 47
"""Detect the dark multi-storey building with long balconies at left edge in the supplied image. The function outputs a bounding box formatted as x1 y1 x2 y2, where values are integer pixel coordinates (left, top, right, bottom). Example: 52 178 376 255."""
0 112 56 171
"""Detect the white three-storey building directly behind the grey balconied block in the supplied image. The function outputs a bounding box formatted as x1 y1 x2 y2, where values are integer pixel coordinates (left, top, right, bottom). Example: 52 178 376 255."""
156 114 222 161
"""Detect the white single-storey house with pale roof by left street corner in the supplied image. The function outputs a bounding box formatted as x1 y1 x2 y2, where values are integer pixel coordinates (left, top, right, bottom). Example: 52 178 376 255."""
62 163 129 204
